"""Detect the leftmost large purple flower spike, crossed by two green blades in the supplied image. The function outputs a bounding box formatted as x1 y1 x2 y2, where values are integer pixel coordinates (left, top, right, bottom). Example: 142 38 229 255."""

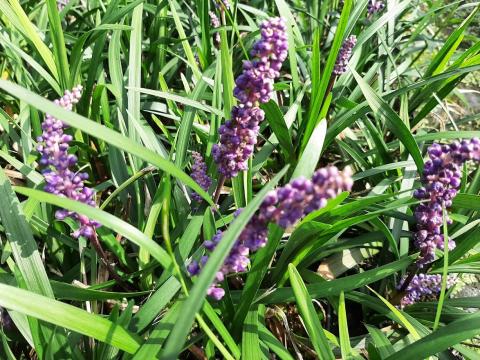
37 85 100 238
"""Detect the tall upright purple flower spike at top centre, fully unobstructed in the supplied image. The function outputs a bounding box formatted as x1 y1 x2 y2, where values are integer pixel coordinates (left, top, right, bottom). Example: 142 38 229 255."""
212 18 288 178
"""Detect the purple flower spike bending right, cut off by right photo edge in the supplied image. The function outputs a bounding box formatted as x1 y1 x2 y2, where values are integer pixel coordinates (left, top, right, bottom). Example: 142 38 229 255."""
413 138 480 267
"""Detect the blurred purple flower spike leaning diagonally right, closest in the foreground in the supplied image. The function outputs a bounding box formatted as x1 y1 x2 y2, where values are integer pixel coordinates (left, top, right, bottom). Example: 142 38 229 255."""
188 166 353 300
